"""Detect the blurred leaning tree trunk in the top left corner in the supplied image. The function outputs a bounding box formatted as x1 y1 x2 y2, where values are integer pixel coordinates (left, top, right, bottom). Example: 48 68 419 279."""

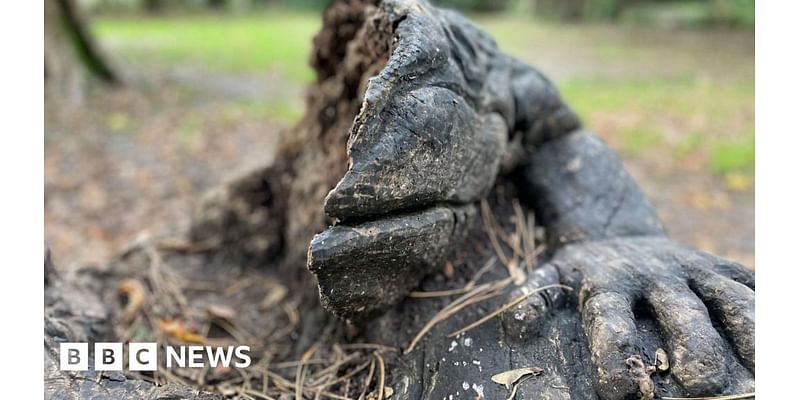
44 0 120 102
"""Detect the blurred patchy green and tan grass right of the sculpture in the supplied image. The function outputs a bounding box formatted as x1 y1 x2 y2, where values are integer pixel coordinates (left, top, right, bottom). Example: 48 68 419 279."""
477 16 755 179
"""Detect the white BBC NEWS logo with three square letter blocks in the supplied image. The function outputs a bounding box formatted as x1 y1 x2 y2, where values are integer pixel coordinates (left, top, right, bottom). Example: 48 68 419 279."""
59 342 251 371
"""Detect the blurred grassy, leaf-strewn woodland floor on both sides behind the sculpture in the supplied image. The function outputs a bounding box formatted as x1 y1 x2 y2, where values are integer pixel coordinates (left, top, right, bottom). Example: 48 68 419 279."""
45 13 755 268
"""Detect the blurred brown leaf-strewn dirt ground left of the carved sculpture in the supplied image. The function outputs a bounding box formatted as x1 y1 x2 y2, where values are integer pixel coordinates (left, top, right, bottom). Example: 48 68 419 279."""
45 69 288 267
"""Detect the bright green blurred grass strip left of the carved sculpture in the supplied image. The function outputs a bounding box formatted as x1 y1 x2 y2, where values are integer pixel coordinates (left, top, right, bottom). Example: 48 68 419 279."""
94 10 321 83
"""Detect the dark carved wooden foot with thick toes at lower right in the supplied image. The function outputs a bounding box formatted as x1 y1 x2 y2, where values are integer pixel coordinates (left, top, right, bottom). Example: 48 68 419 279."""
503 237 755 399
